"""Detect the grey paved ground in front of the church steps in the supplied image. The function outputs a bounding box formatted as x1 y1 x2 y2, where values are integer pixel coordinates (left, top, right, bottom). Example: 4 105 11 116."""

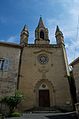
5 112 78 119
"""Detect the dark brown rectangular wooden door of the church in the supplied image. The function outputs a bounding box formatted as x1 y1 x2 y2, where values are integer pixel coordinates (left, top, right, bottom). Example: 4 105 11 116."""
39 89 50 107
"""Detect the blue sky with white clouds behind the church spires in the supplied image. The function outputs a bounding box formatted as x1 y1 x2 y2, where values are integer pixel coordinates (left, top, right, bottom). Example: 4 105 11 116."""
0 0 79 63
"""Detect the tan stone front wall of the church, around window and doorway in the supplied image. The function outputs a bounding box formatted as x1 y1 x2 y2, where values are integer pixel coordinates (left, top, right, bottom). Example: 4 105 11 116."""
19 46 71 109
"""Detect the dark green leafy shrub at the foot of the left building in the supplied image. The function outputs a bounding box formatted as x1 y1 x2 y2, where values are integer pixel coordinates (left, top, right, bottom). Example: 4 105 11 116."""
1 91 23 113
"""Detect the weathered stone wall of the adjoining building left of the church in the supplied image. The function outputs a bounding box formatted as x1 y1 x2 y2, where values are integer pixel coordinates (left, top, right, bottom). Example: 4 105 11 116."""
0 45 20 97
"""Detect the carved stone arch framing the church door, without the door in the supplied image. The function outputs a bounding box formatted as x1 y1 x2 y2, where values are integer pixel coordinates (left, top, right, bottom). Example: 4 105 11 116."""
34 79 56 107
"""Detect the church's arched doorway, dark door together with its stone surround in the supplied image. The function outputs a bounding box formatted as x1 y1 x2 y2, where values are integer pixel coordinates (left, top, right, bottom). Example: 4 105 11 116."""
34 79 55 107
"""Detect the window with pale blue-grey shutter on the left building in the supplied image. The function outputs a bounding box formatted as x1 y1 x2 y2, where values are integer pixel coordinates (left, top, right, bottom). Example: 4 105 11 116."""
0 58 9 71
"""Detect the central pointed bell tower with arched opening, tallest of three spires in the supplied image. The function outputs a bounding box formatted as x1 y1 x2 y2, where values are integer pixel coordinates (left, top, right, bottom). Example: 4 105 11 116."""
35 17 50 44
